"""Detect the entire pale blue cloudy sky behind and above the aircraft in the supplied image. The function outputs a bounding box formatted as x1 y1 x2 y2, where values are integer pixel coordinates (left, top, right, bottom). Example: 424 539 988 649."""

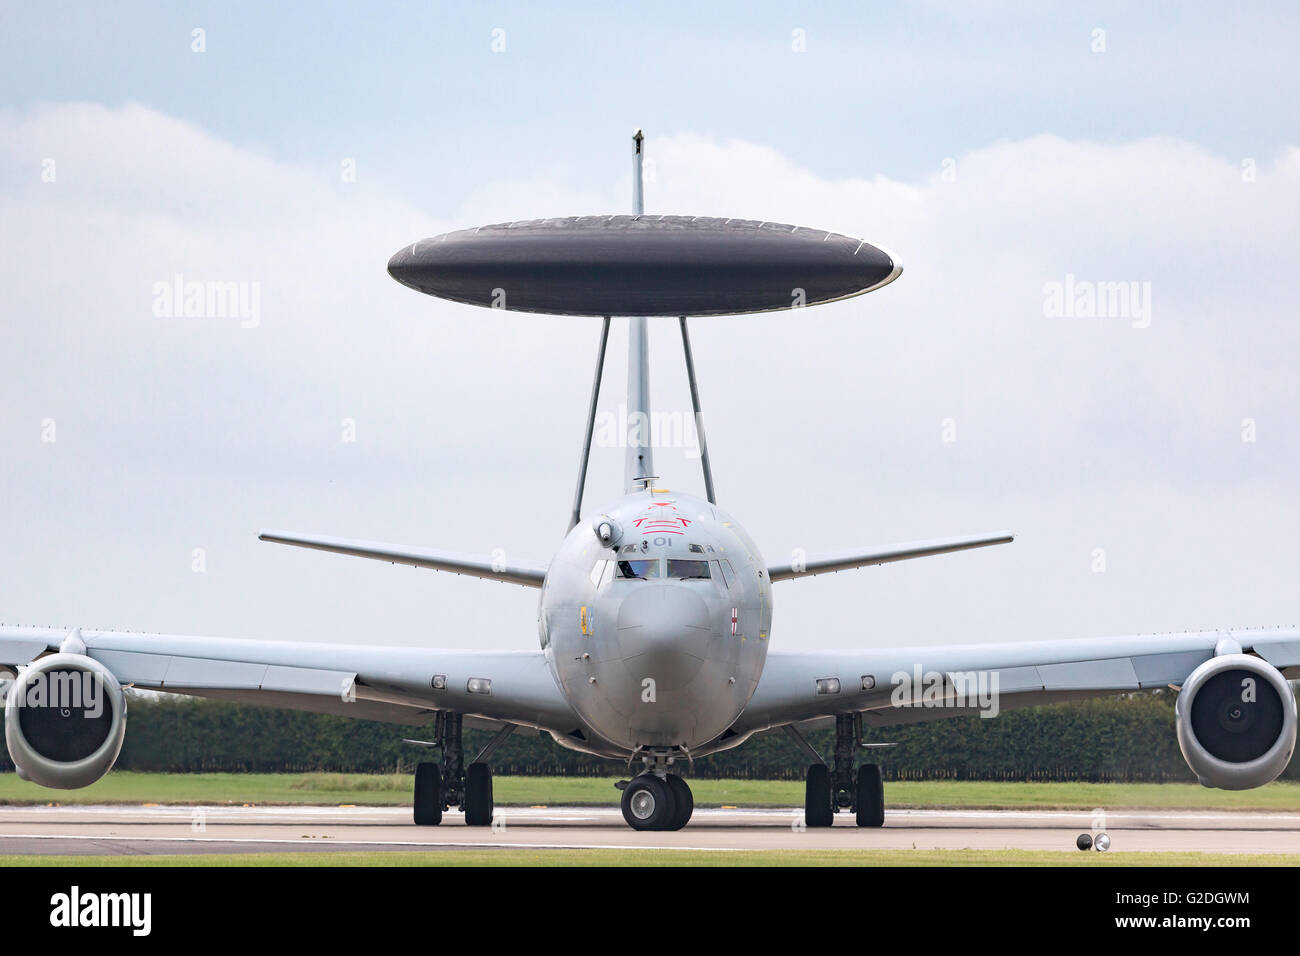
0 0 1300 650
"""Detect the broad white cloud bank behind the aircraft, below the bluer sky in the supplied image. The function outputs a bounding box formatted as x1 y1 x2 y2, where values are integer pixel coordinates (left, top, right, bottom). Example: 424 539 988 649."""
0 103 1300 648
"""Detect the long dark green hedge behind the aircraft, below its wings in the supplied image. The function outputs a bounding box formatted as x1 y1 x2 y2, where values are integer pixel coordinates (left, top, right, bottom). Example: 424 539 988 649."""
4 691 1297 780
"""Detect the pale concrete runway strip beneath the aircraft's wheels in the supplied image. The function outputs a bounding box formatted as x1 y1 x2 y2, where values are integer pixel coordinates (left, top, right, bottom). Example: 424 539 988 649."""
0 805 1300 856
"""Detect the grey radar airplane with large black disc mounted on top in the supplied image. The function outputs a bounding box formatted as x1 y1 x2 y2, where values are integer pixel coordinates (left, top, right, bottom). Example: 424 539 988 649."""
0 131 1300 830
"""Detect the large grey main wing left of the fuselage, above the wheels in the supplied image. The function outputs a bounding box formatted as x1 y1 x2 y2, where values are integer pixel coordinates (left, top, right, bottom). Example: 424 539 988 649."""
0 626 577 734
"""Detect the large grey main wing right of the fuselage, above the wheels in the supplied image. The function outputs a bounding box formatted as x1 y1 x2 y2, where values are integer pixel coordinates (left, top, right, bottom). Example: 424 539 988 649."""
733 630 1300 735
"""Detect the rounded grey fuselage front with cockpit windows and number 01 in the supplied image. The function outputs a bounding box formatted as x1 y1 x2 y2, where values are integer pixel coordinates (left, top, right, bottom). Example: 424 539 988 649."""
538 488 772 756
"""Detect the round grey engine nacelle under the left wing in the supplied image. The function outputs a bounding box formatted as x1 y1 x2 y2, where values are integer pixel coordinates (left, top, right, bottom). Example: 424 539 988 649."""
4 654 126 790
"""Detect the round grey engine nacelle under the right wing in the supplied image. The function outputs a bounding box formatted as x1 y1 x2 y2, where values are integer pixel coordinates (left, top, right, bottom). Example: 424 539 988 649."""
1174 654 1296 790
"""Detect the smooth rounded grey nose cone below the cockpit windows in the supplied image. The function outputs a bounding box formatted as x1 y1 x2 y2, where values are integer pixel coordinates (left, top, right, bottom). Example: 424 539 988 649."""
619 583 710 691
